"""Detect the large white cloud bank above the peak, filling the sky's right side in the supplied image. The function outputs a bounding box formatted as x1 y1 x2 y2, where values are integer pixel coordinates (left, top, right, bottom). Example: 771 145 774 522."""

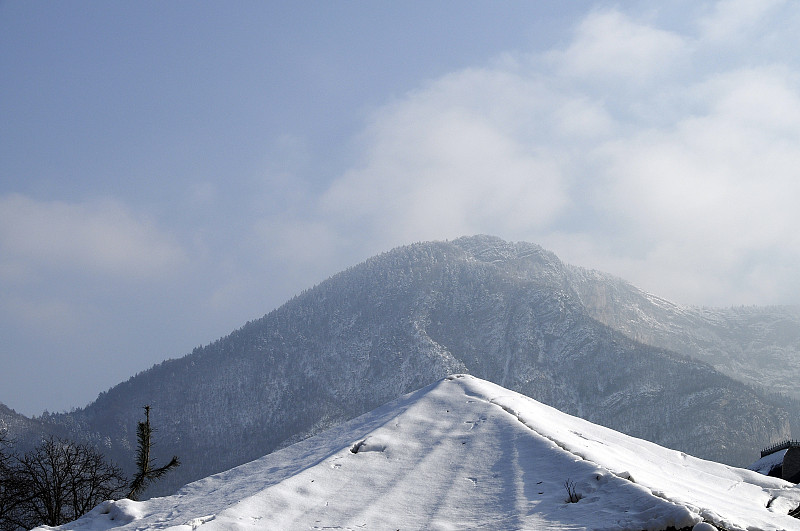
294 2 800 305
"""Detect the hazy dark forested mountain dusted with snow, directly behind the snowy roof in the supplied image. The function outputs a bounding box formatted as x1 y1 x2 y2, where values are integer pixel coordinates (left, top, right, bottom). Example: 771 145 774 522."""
7 236 793 494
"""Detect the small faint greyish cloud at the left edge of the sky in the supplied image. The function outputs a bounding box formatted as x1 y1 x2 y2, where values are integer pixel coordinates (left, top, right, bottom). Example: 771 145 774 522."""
0 194 184 279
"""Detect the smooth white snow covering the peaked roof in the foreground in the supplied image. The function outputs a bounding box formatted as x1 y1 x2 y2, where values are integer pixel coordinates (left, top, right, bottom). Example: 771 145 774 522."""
34 375 800 531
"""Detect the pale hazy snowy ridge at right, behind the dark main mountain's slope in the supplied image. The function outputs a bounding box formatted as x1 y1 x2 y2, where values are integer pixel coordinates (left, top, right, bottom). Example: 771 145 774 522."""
571 267 800 399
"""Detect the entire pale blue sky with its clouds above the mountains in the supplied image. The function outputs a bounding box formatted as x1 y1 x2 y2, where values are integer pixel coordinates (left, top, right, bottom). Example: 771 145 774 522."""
0 0 800 414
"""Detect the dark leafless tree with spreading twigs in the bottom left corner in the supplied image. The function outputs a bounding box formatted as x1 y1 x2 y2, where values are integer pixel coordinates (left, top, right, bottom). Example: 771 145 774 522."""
3 437 126 529
